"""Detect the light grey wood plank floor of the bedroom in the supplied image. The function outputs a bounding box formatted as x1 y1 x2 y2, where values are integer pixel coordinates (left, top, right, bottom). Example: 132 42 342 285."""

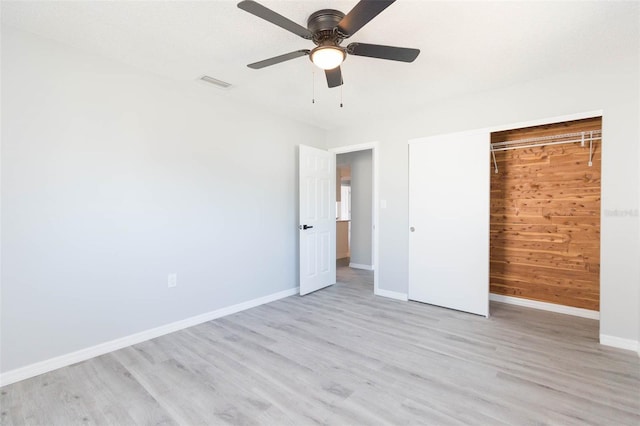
0 267 640 426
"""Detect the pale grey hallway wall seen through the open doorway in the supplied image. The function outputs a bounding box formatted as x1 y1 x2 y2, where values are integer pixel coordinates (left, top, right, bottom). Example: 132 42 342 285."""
336 149 373 267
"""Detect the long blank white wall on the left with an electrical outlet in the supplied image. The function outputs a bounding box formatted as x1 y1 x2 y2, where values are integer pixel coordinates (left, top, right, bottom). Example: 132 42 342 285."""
0 26 324 372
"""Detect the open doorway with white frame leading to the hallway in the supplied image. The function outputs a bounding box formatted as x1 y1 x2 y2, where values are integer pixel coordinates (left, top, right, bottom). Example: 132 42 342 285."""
330 143 379 294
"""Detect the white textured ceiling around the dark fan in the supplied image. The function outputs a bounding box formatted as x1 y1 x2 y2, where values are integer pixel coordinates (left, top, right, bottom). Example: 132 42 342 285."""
2 0 638 129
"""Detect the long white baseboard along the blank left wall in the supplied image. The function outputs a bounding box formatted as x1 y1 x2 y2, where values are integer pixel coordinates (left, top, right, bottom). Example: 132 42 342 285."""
0 287 300 387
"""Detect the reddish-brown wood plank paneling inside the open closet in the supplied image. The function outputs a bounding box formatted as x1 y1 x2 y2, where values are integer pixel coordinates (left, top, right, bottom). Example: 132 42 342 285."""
489 118 602 311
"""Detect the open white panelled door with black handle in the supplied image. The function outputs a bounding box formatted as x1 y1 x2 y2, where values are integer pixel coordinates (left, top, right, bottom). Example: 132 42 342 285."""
298 145 336 295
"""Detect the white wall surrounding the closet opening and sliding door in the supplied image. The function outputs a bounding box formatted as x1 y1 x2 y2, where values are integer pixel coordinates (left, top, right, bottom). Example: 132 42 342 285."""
327 23 640 343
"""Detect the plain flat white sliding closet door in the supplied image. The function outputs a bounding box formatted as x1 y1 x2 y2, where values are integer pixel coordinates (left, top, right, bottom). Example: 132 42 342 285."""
409 131 490 316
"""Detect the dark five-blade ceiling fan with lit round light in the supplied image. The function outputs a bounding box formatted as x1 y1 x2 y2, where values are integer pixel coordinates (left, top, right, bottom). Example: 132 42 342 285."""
238 0 420 87
